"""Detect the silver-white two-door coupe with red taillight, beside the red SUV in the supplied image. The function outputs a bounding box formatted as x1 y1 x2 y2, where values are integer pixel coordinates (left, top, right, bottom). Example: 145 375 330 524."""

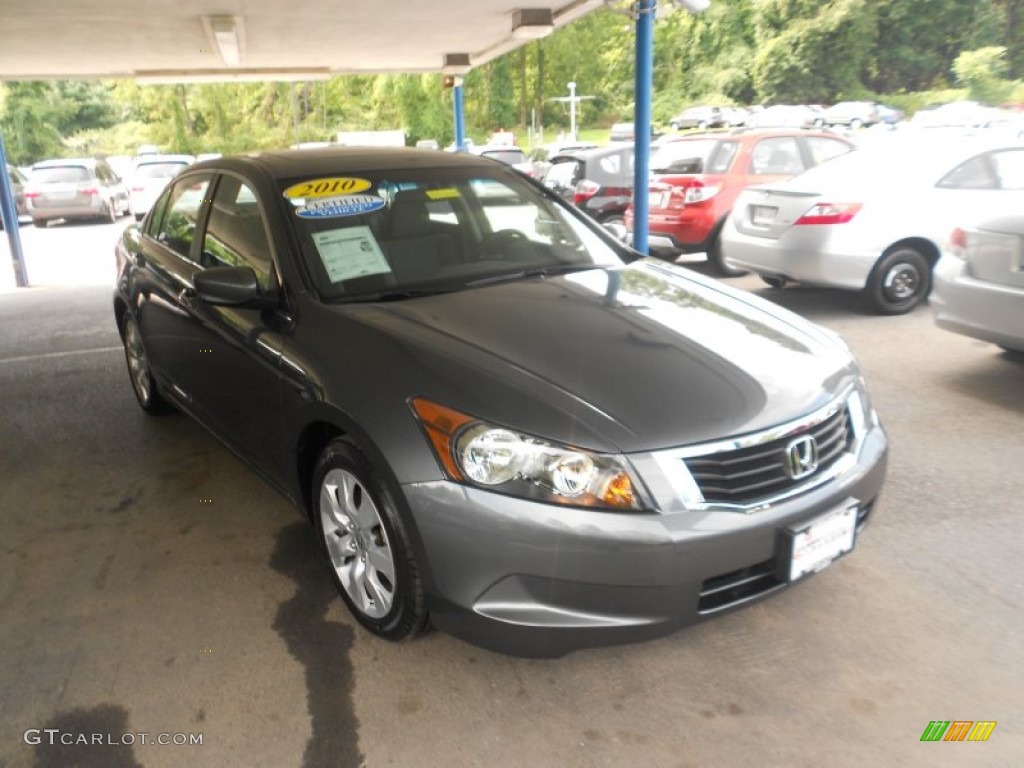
722 136 1024 314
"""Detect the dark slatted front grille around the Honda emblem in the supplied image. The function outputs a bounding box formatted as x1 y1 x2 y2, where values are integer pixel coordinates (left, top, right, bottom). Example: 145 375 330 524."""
684 408 854 504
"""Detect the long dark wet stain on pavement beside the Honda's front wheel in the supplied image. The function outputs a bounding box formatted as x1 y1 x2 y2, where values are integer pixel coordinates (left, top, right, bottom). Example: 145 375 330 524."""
270 522 364 768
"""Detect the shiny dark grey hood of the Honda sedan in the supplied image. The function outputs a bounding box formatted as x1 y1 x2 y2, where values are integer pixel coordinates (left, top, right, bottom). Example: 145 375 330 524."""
327 260 856 453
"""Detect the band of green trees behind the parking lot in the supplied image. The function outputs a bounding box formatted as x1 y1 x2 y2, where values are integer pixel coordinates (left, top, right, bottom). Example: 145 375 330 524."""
0 0 1024 163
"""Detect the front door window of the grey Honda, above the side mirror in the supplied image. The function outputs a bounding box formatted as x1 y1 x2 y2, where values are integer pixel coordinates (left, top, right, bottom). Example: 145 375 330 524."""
203 176 272 289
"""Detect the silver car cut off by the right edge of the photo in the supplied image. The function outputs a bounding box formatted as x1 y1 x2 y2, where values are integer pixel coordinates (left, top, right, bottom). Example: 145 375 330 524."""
932 209 1024 352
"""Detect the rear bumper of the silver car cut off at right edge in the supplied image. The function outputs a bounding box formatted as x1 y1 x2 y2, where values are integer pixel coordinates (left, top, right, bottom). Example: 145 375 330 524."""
931 256 1024 350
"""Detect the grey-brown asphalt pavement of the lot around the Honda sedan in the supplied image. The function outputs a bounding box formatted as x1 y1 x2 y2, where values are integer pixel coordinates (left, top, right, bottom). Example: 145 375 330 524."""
0 222 1024 768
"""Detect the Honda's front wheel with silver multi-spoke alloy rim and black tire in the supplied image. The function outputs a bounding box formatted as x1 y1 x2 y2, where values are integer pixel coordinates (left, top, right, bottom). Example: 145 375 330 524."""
312 439 428 642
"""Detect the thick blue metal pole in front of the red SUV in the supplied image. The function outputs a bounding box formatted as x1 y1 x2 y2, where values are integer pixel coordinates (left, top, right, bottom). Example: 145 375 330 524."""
633 0 657 255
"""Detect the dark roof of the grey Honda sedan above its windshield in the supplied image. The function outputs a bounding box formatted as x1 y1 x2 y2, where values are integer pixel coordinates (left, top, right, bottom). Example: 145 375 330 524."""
189 146 507 178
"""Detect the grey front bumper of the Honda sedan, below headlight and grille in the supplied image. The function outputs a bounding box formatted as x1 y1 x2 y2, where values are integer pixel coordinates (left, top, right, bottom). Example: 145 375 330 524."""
404 425 888 657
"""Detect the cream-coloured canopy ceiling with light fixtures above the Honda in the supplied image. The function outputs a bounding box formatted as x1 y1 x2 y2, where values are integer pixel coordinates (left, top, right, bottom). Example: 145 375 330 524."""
0 0 604 82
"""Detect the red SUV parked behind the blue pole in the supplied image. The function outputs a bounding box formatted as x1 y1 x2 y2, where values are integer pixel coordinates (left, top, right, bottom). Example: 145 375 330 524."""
626 129 853 275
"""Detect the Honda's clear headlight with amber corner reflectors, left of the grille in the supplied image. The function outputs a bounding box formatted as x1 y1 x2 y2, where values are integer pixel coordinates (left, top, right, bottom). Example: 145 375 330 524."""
413 398 640 510
